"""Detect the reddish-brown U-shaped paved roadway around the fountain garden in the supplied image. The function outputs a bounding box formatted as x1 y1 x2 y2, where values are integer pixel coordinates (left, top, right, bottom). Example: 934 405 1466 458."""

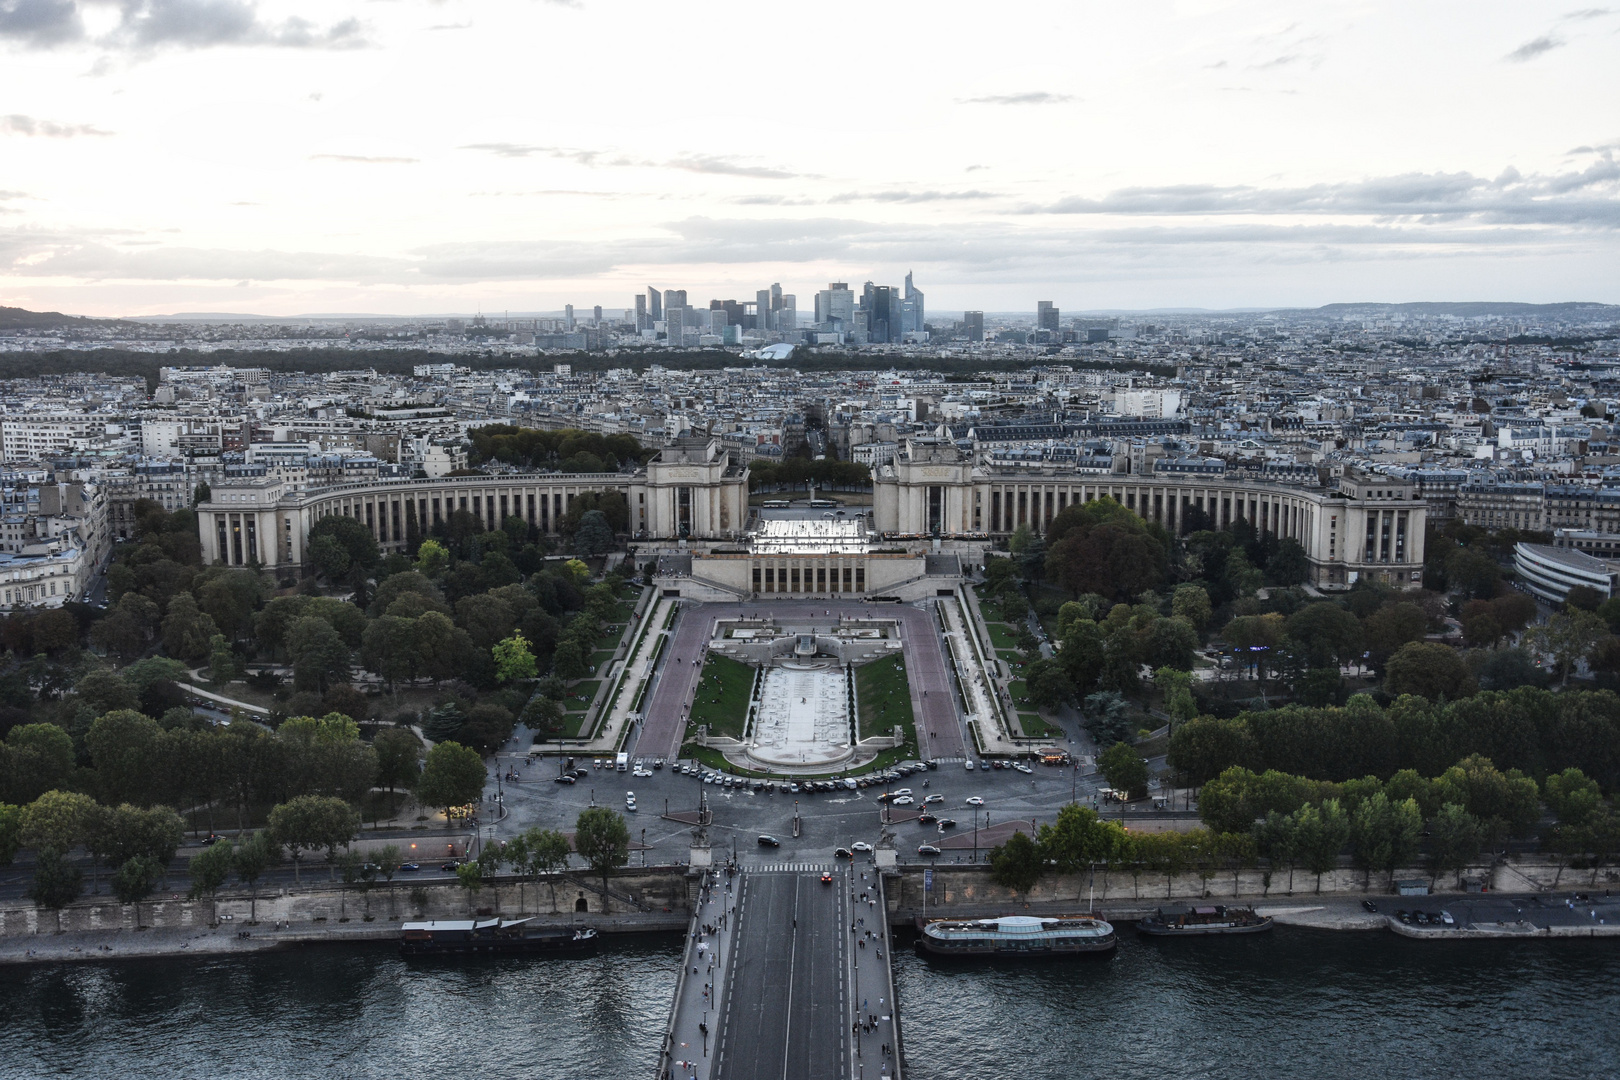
635 597 967 759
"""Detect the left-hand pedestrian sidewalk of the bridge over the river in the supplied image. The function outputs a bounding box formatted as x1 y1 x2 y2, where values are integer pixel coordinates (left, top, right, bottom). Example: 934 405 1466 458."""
658 870 742 1080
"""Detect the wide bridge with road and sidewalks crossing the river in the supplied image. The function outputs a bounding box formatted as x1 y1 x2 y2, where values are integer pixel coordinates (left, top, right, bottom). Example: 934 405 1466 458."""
658 863 901 1080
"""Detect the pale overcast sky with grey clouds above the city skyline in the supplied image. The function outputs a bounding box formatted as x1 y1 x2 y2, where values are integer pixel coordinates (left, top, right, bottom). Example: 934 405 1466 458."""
0 0 1620 316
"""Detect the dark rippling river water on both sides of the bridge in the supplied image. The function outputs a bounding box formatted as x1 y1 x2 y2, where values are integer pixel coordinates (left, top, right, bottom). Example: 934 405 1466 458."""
0 928 1620 1080
